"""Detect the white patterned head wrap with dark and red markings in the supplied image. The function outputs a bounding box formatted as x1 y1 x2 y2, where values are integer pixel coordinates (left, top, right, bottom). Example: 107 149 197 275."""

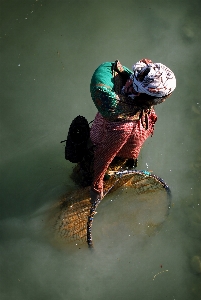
131 59 176 97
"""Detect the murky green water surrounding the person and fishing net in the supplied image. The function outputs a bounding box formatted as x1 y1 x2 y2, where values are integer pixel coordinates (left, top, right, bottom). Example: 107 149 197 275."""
0 0 201 300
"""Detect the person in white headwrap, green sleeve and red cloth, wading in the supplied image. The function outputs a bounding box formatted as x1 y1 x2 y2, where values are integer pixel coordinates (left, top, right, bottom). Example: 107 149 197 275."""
90 58 176 203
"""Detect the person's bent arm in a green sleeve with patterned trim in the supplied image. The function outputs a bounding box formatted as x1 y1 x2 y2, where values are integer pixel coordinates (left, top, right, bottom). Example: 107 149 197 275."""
90 60 140 121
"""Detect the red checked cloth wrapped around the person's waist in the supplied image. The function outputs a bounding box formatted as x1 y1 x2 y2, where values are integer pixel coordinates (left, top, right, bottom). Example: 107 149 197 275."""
90 109 157 194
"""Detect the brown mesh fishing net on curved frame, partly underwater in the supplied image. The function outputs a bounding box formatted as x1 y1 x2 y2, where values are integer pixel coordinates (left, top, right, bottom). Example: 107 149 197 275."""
54 170 171 247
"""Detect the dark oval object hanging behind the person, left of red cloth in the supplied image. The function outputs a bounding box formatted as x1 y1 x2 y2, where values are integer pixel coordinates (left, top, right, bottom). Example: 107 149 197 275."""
62 116 90 163
